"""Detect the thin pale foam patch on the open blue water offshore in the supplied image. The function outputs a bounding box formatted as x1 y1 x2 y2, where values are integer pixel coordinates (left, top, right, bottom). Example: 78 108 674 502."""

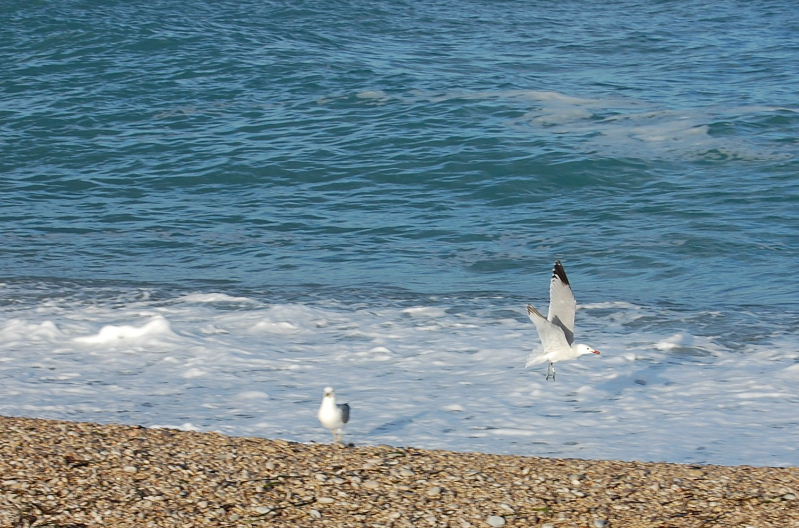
396 90 799 161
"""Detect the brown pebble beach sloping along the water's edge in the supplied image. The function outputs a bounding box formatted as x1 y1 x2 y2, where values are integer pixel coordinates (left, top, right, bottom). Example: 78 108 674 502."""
0 416 799 528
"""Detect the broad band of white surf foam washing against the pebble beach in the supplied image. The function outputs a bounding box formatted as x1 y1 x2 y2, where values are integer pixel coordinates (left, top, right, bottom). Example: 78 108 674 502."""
0 288 799 465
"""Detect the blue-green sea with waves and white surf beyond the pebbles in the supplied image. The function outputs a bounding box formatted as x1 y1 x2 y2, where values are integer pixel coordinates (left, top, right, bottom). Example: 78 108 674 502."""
0 0 799 466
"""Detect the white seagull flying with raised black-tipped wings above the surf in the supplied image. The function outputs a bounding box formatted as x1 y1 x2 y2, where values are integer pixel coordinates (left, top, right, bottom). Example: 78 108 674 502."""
526 260 599 381
